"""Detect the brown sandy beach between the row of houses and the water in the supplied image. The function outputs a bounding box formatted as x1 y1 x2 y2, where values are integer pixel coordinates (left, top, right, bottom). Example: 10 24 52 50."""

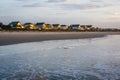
0 32 120 46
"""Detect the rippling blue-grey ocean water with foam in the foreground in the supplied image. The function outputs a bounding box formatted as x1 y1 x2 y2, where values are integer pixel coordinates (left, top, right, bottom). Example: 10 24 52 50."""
0 35 120 80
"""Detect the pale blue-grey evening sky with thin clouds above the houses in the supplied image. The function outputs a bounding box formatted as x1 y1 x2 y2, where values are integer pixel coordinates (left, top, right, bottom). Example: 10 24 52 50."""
0 0 120 28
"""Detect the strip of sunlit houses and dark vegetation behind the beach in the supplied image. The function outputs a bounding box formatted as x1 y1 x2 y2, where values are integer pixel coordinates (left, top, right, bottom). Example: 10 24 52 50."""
0 21 120 32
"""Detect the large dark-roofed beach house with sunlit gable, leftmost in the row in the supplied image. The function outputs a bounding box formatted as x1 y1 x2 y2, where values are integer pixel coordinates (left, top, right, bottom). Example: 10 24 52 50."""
8 21 25 29
